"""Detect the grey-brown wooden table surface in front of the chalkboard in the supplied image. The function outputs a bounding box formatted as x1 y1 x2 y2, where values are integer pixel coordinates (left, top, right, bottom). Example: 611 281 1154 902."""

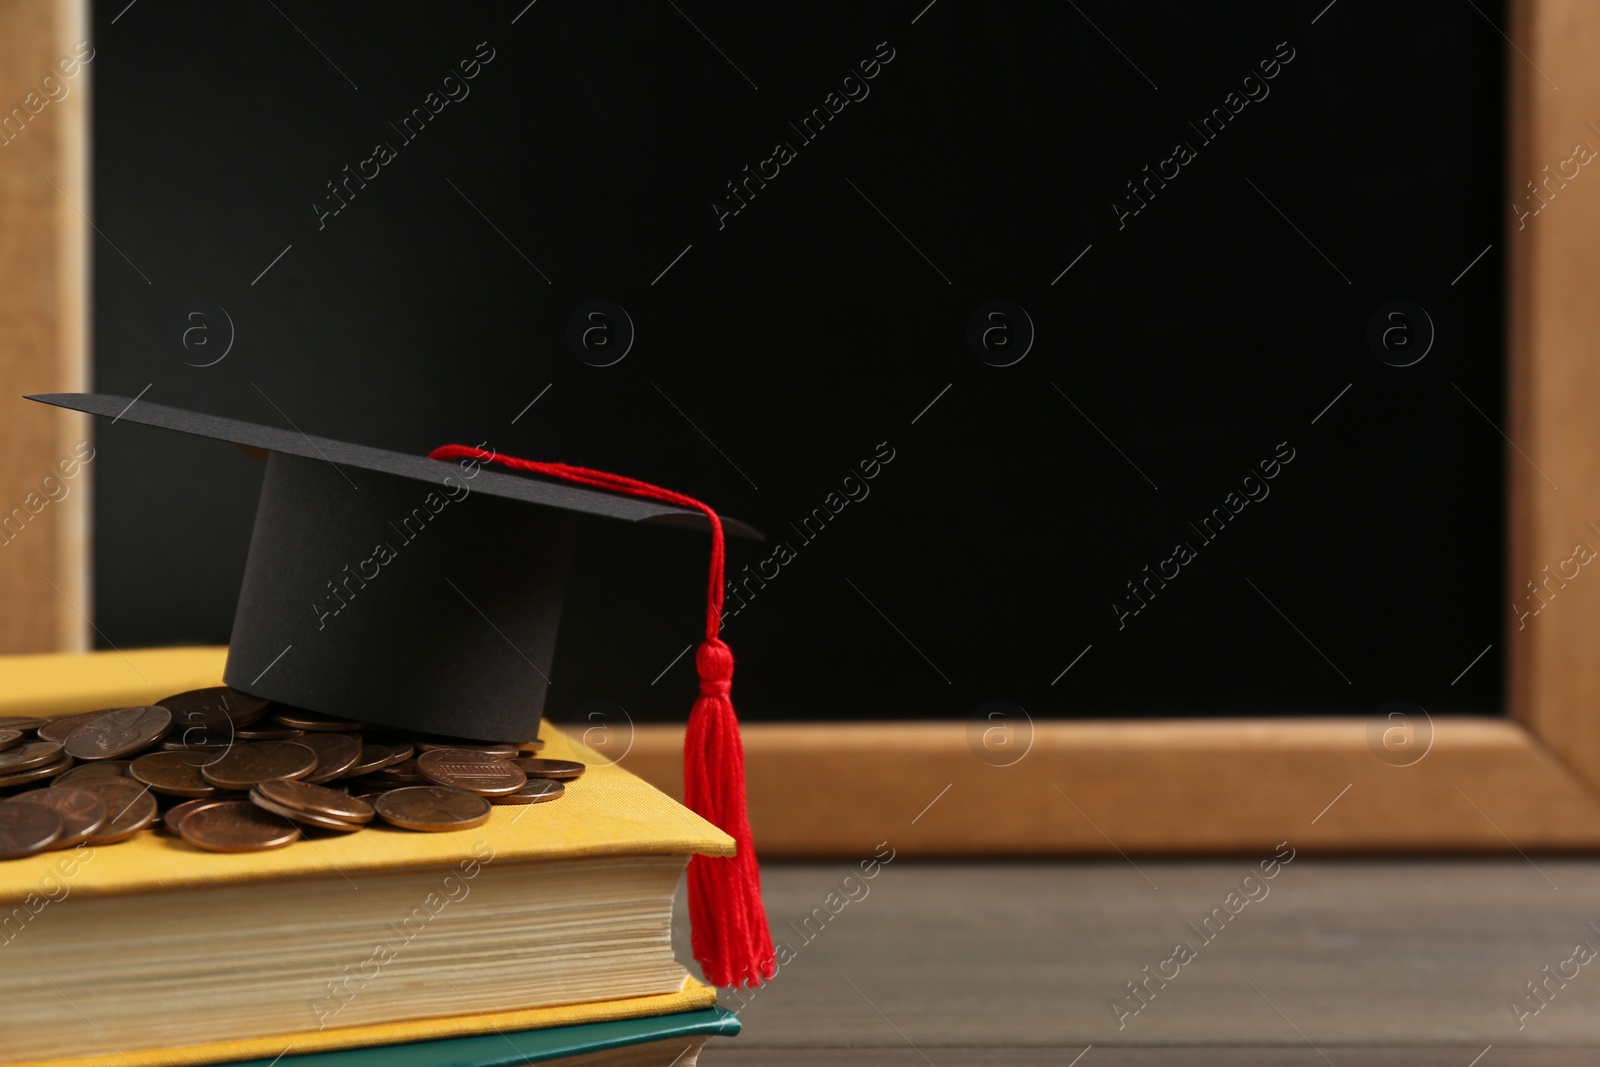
677 856 1600 1067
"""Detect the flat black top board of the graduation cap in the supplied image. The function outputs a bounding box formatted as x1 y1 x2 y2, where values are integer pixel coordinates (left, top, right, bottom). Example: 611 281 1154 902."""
27 394 762 541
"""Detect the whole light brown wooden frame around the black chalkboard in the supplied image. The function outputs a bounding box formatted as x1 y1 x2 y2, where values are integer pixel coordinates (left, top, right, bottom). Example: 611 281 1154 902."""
0 0 1600 857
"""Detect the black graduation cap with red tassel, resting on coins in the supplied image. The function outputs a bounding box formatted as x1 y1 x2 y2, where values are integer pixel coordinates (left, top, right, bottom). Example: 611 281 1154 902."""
29 394 776 985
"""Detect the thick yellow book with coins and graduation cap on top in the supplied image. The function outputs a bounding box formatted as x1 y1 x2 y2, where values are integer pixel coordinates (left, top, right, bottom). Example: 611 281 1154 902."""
0 649 733 1067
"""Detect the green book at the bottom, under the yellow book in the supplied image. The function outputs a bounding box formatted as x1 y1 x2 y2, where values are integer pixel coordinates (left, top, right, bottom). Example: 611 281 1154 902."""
219 1008 739 1067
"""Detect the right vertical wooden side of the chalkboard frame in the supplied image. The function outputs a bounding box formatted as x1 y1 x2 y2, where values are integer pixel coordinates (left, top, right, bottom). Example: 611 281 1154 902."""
1504 0 1600 789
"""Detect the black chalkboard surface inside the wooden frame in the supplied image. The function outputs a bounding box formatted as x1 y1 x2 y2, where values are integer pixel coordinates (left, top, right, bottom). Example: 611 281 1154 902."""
93 0 1515 720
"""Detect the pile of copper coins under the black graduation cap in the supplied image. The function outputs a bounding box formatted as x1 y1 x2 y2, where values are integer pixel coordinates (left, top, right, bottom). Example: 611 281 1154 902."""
0 686 584 859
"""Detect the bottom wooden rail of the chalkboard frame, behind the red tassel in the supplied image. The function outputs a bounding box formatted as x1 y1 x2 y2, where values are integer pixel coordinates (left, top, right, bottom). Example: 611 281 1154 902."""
601 717 1600 857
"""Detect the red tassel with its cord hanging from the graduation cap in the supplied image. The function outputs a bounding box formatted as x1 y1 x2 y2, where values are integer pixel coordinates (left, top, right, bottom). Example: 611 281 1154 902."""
429 445 778 985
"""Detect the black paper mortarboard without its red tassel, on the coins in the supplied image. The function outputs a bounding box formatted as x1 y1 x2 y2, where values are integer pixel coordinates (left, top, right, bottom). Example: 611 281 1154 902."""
29 394 757 741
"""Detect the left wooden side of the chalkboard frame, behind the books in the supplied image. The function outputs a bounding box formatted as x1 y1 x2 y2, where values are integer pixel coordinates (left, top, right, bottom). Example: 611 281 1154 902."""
0 0 90 653
